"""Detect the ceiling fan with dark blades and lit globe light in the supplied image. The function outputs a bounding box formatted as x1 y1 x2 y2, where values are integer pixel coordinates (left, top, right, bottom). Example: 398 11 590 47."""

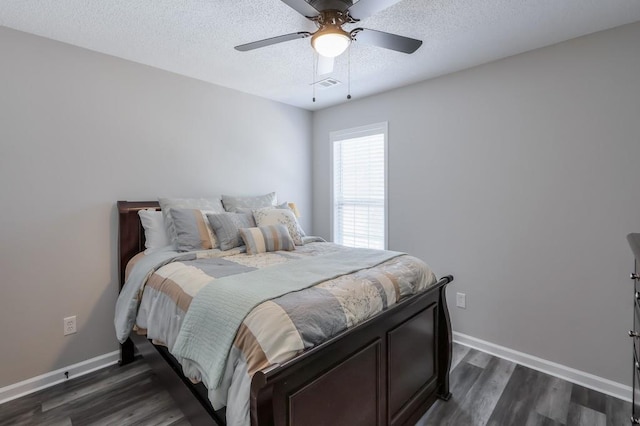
235 0 422 62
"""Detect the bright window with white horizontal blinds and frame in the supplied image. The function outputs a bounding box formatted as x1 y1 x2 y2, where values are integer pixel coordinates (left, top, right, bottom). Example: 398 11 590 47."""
330 122 387 249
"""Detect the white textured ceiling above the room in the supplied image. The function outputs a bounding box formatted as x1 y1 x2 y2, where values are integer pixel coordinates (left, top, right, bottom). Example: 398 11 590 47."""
0 0 640 110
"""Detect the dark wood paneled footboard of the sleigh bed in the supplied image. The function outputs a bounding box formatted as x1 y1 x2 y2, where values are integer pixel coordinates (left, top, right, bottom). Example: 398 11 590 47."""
251 276 453 426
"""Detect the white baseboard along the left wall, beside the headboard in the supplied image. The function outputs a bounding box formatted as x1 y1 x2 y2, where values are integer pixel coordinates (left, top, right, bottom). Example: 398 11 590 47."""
0 351 120 404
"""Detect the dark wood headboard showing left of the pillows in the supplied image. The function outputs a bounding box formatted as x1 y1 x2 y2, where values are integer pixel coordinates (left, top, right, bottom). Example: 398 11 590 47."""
118 201 160 288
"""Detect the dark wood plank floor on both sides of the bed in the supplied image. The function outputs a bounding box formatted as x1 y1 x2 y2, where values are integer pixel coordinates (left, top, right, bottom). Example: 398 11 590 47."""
0 345 631 426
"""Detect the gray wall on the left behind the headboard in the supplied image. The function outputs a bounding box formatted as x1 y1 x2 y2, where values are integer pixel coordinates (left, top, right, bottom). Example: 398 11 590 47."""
0 27 312 387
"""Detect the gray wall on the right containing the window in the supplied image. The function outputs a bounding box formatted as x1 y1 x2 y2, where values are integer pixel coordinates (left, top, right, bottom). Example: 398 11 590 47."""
313 23 640 385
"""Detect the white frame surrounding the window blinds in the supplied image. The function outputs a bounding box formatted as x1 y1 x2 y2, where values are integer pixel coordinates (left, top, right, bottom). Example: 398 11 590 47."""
329 121 389 250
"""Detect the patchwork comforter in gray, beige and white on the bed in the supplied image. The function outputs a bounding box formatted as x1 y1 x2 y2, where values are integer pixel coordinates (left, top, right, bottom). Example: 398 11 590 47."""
115 242 437 426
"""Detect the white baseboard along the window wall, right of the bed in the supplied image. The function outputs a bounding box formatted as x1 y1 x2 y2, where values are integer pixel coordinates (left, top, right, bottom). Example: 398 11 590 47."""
453 331 633 402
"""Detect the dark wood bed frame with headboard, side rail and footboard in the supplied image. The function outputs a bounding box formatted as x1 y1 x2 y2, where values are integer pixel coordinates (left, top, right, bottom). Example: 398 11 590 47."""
118 201 453 426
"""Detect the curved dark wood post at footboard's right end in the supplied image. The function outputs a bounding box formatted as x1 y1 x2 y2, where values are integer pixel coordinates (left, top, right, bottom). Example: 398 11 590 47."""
437 275 453 401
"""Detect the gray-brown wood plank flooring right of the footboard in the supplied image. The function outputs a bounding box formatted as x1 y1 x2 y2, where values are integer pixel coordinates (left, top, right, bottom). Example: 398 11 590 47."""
416 344 631 426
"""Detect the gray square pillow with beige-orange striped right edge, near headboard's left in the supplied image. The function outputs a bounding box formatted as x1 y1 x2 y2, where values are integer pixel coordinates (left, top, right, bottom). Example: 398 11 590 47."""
171 208 218 251
